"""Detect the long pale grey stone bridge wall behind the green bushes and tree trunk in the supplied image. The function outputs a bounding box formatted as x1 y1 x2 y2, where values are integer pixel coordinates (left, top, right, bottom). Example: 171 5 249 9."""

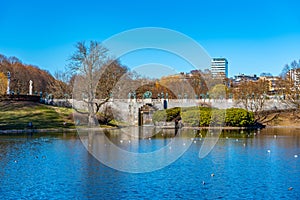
69 99 289 125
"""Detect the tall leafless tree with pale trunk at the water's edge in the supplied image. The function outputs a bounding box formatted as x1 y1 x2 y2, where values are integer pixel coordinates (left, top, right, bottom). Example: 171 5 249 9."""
69 41 110 125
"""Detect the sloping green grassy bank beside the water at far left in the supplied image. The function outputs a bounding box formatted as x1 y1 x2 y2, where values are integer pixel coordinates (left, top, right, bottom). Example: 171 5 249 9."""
0 101 75 130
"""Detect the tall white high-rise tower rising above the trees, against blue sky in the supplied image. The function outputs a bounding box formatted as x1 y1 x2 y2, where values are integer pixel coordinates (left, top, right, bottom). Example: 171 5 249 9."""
210 58 228 78
